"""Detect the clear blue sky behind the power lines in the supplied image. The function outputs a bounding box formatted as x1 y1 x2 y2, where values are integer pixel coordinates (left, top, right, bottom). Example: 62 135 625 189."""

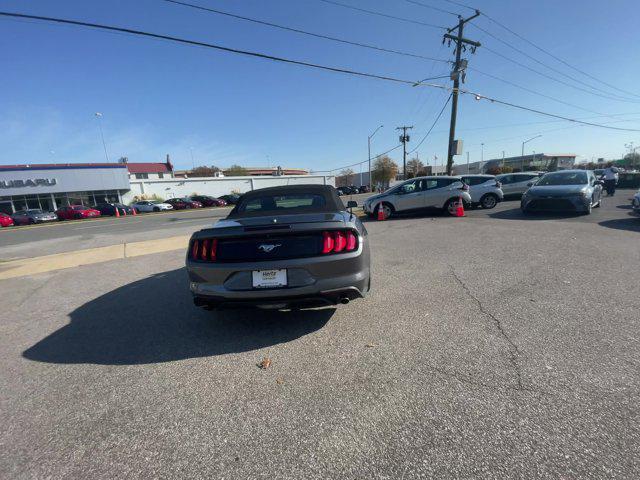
0 0 640 171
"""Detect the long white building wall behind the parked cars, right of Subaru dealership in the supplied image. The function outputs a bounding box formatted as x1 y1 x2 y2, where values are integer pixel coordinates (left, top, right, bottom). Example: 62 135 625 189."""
122 175 335 203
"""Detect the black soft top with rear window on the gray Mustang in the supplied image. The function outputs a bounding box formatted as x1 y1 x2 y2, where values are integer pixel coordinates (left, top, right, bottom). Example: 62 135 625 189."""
228 185 345 218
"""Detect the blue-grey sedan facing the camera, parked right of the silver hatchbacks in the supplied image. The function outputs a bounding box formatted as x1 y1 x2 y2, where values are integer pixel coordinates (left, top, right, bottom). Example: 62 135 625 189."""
520 170 602 214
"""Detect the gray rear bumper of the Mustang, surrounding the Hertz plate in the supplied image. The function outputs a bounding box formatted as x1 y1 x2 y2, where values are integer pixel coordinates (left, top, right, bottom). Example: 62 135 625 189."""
187 245 370 308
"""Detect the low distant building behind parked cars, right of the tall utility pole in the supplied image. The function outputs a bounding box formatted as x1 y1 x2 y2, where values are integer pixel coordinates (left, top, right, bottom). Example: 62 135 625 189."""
453 153 576 175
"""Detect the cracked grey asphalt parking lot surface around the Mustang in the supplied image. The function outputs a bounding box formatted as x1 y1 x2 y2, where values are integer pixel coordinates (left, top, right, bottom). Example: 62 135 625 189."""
0 191 640 479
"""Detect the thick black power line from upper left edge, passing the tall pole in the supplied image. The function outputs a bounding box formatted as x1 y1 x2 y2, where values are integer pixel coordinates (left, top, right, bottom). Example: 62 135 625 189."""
5 9 640 132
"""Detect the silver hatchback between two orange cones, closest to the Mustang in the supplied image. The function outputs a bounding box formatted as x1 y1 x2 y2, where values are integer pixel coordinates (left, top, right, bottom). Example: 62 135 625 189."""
363 176 471 217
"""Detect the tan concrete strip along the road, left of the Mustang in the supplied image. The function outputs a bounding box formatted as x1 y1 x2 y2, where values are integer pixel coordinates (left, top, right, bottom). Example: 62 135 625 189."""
0 235 191 280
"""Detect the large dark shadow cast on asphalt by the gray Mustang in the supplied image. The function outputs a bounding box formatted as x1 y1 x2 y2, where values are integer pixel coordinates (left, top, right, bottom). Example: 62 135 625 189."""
23 268 335 365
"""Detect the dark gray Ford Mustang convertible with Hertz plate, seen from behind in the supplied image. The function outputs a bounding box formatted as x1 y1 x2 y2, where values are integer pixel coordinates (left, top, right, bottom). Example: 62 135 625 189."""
186 185 371 309
